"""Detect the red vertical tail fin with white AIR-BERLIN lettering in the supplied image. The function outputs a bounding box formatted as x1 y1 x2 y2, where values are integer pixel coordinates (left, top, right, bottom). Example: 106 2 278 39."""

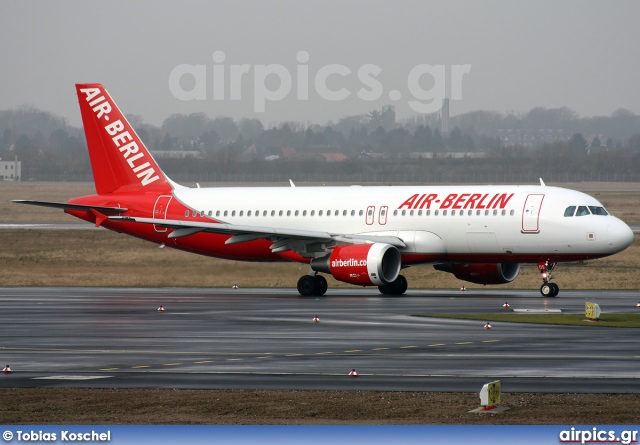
76 83 172 195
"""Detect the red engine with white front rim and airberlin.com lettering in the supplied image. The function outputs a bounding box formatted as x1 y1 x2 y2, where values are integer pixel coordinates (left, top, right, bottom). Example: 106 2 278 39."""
311 243 402 286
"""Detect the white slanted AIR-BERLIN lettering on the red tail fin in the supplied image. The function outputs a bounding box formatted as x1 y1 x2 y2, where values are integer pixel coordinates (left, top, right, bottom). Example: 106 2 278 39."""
80 88 160 186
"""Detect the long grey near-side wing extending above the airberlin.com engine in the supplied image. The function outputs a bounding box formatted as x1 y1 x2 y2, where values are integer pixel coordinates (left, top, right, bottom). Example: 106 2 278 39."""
109 216 406 252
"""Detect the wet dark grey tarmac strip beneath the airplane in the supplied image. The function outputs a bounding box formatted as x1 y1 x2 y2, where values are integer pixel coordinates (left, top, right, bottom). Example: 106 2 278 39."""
0 288 640 393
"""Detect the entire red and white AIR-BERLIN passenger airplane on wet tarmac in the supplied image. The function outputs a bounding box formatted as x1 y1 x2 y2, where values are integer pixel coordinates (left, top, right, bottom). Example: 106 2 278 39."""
14 84 634 297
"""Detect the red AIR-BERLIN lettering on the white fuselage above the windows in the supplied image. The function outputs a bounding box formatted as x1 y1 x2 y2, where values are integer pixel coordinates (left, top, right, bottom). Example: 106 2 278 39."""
398 193 514 210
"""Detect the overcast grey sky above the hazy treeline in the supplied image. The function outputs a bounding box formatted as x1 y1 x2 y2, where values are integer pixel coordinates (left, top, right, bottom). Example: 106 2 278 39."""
0 0 640 125
